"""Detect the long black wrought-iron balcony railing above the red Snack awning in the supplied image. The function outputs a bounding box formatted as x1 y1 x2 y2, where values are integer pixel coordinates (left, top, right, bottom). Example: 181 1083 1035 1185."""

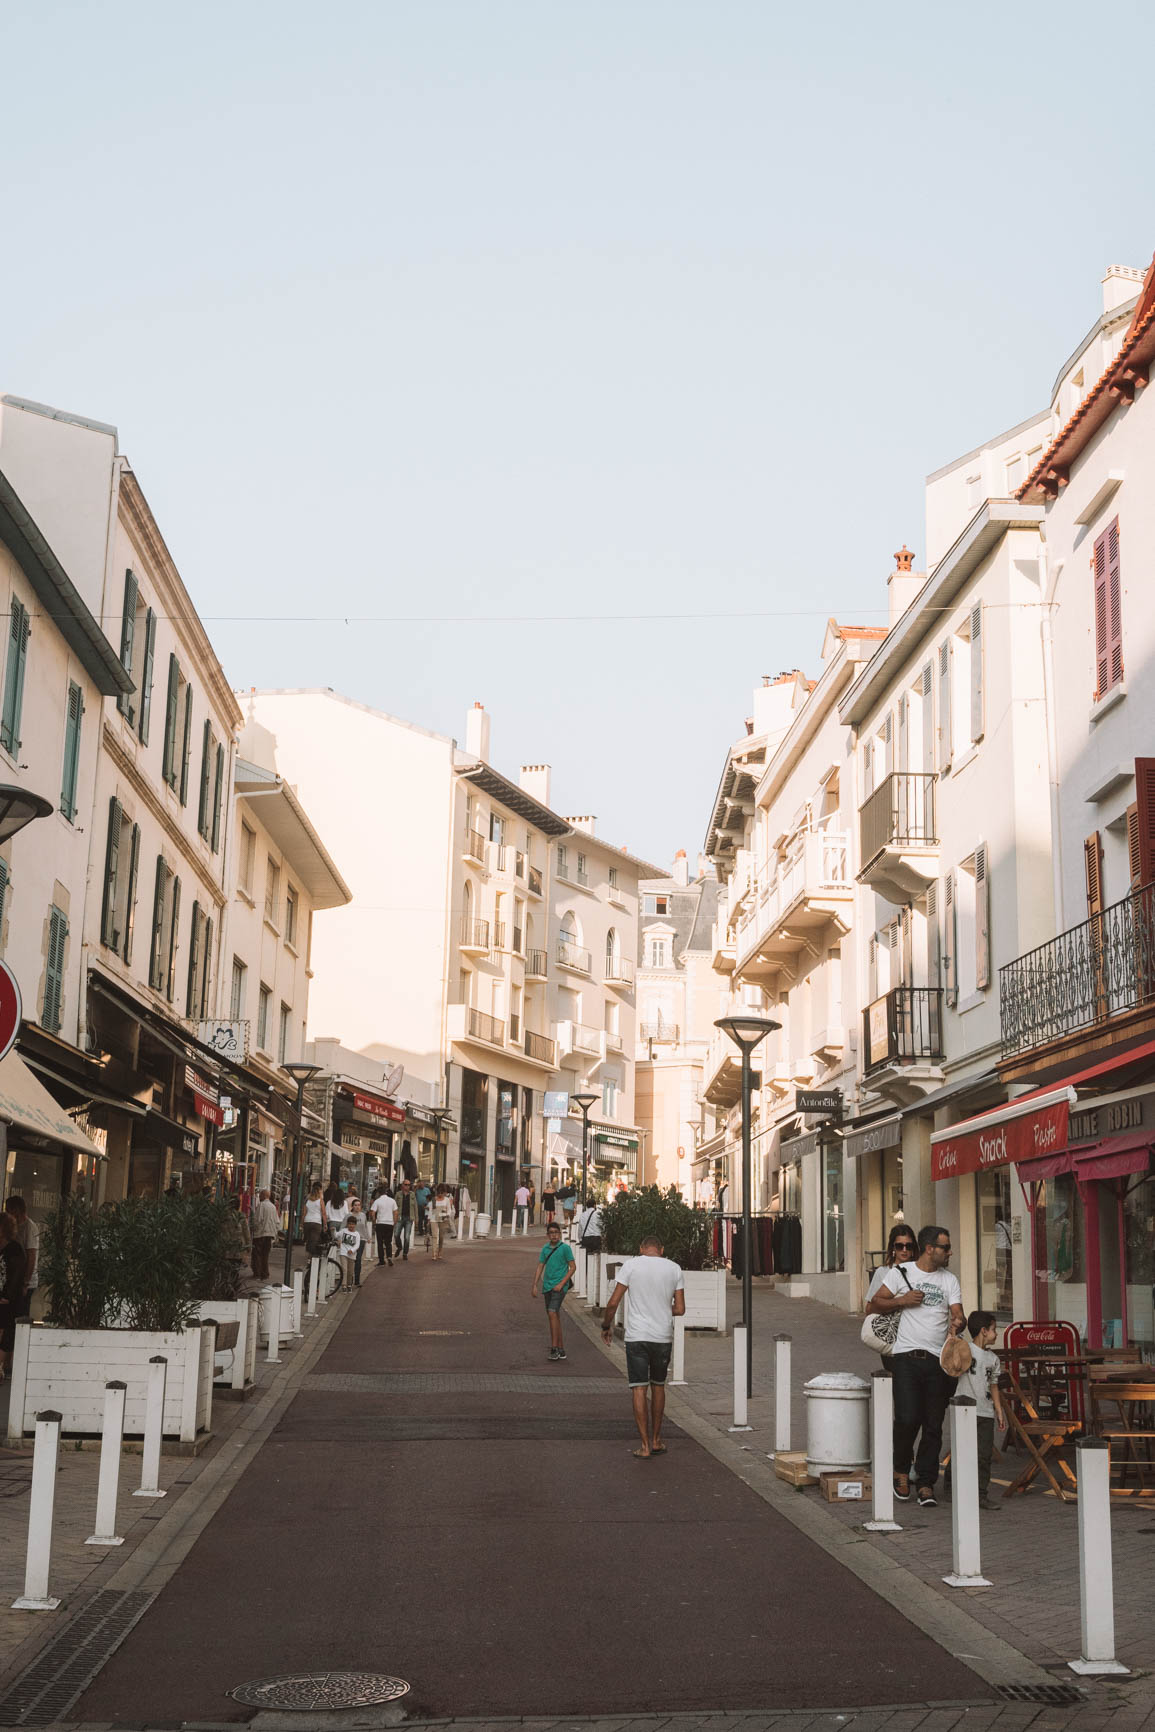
999 883 1155 1057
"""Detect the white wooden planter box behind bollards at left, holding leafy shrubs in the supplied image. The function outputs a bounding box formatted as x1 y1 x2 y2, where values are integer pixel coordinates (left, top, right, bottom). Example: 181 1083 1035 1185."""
7 1320 213 1444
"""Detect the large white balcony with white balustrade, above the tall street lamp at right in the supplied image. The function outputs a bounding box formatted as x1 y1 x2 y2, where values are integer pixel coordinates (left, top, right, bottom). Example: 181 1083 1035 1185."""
734 830 854 980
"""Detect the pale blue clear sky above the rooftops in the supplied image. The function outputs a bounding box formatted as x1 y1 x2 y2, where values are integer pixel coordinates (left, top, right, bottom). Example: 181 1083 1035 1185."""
0 0 1155 863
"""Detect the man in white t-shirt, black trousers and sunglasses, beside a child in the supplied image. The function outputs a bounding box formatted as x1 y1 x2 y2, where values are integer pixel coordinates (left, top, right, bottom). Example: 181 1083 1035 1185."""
868 1226 966 1509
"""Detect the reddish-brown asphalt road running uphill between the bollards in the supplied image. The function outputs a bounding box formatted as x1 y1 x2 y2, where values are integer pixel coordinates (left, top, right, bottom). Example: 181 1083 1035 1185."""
73 1240 990 1723
